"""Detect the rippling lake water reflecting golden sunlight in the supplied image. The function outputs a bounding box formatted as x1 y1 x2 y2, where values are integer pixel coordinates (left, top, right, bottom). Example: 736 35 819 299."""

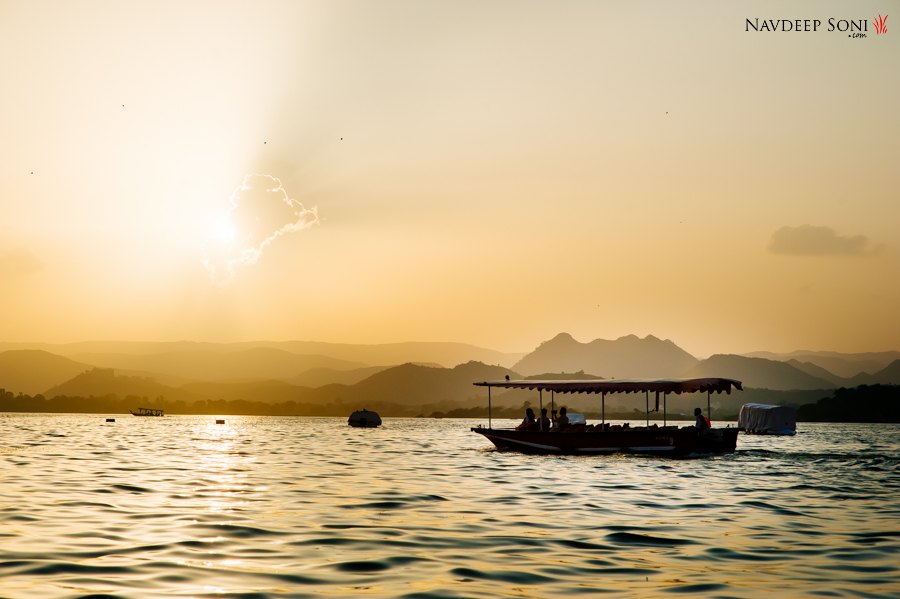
0 414 900 599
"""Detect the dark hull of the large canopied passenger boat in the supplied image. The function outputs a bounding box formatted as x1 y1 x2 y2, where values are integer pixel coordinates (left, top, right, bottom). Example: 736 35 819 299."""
472 427 738 457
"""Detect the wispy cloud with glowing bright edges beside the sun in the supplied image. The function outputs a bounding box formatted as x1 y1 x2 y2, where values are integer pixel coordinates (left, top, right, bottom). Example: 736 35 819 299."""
203 174 319 283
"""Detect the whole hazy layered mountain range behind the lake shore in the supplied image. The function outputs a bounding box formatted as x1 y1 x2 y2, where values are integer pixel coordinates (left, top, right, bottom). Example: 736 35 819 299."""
0 333 900 409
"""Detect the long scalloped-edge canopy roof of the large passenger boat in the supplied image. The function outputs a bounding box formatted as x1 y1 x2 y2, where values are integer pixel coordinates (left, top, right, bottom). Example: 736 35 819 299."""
473 378 743 394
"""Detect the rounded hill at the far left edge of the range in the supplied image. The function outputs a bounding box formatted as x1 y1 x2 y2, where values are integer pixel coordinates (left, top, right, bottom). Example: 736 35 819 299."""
0 349 91 395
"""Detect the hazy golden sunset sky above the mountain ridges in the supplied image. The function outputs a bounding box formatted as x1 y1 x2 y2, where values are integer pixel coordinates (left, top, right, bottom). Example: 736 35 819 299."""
0 0 900 357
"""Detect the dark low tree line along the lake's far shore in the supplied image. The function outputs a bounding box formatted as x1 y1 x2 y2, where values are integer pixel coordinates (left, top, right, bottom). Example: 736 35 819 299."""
0 385 900 422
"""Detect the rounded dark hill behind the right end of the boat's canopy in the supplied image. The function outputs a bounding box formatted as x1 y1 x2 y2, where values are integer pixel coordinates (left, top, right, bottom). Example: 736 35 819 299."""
682 354 834 391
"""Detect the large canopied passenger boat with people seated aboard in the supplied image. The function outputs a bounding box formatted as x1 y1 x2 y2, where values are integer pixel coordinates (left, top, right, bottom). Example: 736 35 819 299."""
471 378 743 457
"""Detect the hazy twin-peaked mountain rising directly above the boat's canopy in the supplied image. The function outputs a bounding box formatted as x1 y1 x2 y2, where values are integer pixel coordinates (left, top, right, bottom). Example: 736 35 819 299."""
512 333 698 378
